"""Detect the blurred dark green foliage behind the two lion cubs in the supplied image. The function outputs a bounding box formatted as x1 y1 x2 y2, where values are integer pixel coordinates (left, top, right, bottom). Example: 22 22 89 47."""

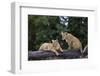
28 15 88 51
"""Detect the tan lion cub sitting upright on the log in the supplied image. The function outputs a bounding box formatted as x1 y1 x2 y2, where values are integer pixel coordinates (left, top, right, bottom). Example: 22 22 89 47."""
61 32 82 53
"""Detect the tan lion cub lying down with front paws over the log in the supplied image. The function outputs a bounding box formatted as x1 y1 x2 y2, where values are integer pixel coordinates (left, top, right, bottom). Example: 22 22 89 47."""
39 40 63 55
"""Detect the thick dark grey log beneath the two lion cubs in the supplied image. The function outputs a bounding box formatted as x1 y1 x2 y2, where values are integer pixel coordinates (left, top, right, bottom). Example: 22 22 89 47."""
28 49 87 60
